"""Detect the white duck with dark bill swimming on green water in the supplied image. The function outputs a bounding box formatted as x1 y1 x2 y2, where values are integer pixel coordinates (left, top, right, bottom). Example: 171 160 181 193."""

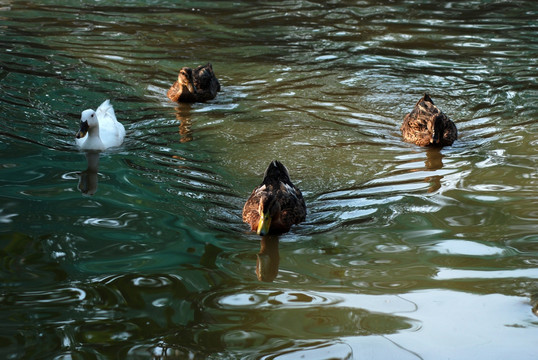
76 100 125 151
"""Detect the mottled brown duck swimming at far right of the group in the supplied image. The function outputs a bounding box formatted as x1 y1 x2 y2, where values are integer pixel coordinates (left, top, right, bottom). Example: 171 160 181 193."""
400 94 458 146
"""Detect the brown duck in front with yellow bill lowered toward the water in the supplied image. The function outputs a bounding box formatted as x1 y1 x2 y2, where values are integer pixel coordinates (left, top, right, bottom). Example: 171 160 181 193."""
243 160 306 236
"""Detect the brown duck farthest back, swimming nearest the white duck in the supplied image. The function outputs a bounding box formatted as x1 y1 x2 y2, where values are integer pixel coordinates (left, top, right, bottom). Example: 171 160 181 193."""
167 63 220 102
